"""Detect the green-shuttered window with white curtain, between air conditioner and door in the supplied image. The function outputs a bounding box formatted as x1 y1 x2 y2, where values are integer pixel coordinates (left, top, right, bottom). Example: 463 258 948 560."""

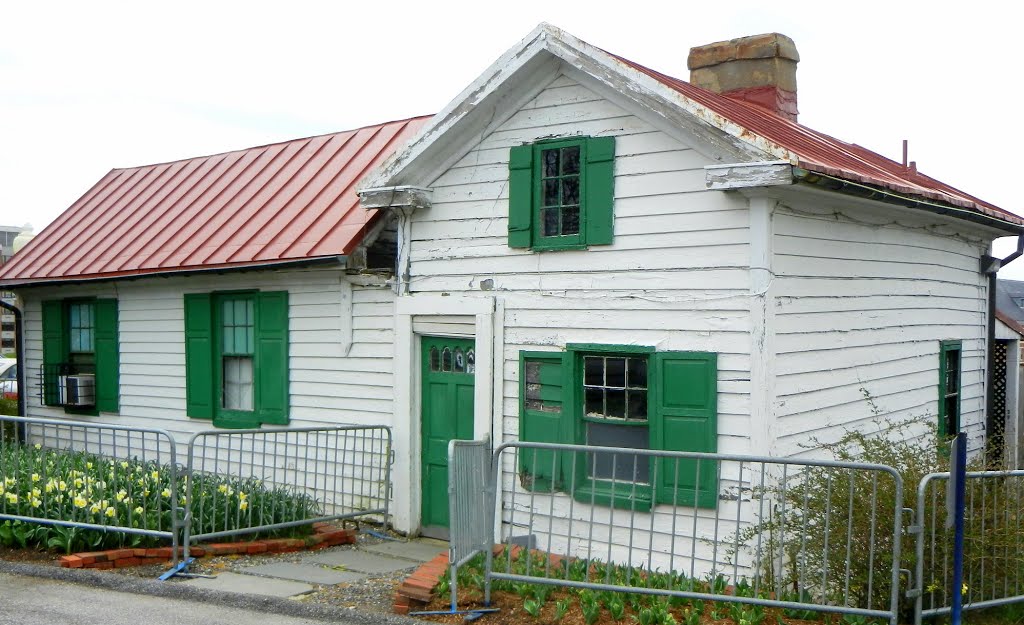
184 291 288 427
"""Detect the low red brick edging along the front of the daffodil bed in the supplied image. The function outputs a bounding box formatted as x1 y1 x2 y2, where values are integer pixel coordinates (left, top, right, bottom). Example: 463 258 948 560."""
58 523 358 570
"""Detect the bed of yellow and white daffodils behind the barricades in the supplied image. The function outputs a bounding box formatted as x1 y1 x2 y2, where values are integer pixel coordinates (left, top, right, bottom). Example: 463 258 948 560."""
0 442 321 553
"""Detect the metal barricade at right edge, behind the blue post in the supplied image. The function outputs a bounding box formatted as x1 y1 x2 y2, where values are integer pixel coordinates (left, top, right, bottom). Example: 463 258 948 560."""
907 470 1024 625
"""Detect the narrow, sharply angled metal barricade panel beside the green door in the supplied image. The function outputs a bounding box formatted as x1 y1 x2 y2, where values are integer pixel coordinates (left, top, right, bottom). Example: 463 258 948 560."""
449 439 494 612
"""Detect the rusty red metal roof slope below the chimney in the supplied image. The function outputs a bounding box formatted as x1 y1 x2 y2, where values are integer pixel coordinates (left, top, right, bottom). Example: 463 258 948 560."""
612 54 1024 225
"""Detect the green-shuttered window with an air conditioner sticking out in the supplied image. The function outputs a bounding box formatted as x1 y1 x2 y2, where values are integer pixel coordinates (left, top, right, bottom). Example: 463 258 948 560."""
40 299 120 415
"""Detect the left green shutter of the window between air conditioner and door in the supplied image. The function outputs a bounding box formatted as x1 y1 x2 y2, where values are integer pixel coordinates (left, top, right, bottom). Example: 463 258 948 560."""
185 293 215 419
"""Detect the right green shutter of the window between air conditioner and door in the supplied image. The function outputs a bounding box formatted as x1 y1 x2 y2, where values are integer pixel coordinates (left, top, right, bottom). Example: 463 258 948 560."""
255 291 288 425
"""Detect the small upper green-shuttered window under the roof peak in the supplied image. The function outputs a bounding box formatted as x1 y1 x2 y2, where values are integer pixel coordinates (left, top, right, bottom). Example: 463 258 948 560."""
509 136 615 250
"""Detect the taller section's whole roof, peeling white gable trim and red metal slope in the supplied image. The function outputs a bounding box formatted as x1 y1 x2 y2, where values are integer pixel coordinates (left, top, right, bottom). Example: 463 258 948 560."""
361 24 1024 232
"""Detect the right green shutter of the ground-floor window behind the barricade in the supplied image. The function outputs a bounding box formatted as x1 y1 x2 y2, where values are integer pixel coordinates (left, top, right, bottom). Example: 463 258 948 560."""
650 351 718 508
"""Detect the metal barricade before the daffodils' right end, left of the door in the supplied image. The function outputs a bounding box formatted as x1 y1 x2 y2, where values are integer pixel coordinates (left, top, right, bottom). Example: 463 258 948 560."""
184 425 393 558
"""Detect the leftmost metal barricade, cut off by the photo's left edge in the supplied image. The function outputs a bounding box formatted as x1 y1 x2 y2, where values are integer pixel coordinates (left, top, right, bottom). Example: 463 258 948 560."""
0 416 182 561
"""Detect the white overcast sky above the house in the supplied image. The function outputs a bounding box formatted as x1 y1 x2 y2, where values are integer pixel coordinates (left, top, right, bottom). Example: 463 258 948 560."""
0 0 1024 272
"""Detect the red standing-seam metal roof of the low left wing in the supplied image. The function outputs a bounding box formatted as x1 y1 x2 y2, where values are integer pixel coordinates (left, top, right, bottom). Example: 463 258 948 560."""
0 117 429 285
